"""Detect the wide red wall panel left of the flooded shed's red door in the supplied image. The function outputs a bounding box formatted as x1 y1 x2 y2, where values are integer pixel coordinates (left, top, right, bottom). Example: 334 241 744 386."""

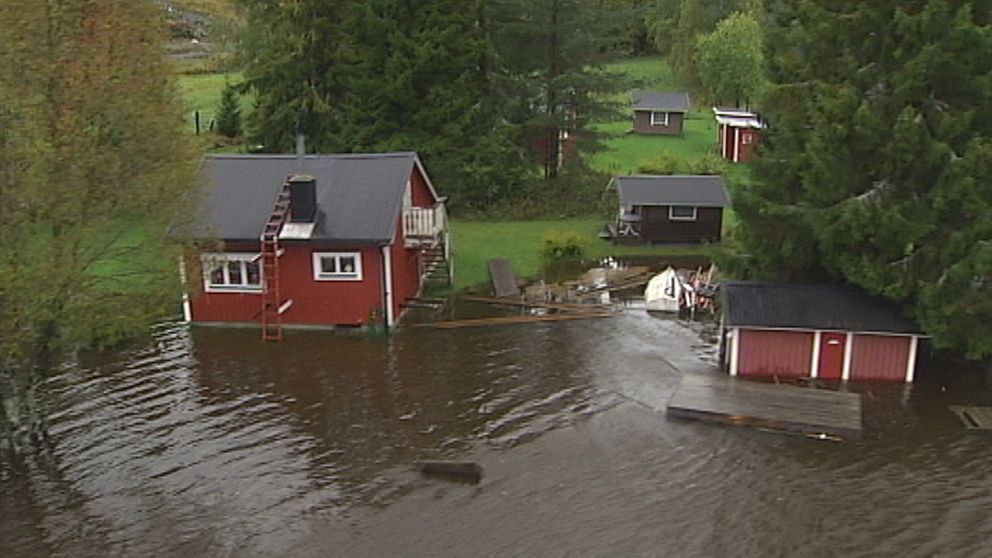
737 329 813 378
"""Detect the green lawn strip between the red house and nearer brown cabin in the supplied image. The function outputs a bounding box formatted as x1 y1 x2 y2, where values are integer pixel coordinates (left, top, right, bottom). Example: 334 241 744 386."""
451 217 714 289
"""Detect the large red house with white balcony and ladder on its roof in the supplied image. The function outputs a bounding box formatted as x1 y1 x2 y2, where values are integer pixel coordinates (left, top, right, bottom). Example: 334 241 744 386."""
184 153 450 339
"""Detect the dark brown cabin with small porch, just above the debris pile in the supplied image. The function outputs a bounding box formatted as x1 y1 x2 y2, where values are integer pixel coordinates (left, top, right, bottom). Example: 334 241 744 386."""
611 175 730 244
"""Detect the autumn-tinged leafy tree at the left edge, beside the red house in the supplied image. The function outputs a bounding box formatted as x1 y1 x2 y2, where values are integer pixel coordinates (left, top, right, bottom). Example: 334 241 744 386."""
0 0 195 447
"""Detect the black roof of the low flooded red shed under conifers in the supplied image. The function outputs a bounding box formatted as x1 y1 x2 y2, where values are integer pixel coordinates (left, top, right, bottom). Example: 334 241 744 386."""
720 281 920 334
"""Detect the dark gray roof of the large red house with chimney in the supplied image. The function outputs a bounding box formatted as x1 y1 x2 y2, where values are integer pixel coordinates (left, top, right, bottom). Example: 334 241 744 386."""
190 152 417 244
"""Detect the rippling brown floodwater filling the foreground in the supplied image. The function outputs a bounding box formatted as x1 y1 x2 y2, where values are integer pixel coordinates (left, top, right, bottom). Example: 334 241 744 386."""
0 307 992 558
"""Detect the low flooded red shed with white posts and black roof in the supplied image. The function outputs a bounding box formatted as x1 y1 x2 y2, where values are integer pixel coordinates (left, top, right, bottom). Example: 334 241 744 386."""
720 281 924 382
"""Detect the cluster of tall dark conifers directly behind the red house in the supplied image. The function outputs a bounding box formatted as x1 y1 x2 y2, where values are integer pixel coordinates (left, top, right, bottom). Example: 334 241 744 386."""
239 0 622 209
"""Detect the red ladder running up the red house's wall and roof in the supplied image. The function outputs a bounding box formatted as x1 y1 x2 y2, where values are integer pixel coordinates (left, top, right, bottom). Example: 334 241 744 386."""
260 179 293 341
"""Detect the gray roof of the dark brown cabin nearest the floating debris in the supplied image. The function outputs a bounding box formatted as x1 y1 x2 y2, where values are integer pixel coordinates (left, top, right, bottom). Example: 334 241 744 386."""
616 175 730 207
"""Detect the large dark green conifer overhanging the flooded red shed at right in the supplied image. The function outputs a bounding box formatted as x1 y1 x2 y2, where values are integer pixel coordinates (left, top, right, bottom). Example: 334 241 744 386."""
736 0 992 358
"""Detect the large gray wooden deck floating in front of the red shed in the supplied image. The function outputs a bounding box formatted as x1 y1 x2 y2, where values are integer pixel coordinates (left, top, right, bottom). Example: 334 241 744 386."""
667 374 861 439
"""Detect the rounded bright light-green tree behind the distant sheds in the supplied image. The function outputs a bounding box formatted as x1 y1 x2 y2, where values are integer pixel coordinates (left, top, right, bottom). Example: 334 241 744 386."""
696 12 765 107
